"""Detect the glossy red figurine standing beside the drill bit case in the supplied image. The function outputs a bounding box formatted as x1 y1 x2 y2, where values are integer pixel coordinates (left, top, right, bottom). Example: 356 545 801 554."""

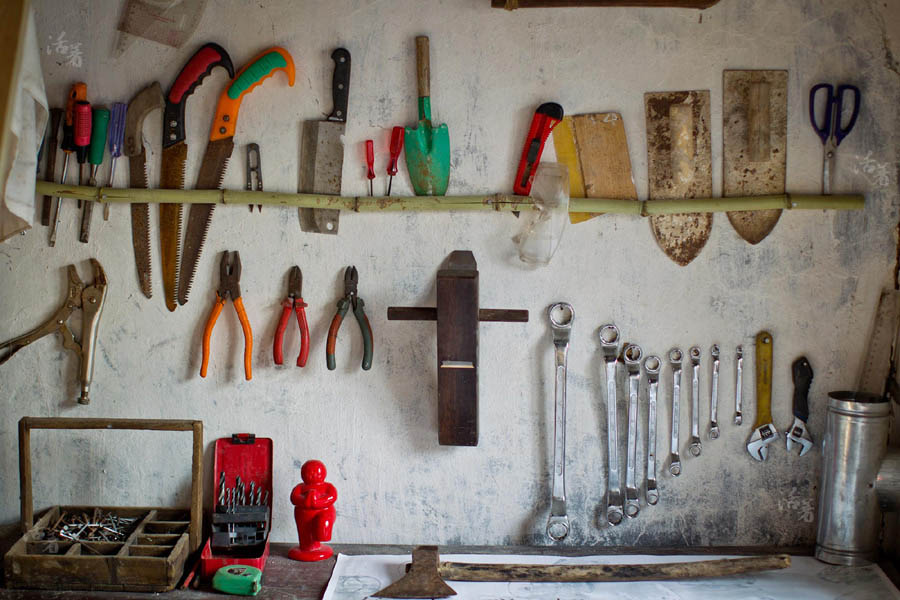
288 460 337 562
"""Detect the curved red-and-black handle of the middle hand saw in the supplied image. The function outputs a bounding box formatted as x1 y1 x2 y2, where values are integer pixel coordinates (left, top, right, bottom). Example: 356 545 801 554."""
162 43 234 148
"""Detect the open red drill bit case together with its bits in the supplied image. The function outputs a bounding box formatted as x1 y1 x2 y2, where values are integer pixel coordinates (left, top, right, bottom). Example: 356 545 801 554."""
200 433 273 579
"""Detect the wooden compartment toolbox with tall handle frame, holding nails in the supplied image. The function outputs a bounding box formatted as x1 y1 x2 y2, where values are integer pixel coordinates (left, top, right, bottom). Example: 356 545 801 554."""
4 417 203 592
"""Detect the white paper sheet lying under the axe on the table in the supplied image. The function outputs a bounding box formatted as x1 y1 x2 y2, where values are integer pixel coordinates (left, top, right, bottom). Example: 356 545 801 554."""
323 554 900 600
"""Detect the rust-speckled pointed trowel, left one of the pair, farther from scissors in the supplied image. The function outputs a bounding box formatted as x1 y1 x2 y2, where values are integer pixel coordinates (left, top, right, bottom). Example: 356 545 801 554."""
644 91 713 266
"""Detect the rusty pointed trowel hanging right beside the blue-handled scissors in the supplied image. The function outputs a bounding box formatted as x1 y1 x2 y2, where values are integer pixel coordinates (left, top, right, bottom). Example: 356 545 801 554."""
722 70 787 244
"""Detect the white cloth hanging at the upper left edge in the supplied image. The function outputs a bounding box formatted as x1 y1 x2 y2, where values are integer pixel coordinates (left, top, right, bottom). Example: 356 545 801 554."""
0 7 48 241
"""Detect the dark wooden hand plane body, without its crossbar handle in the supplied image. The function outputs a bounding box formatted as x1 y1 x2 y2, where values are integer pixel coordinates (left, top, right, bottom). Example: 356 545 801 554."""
437 250 478 446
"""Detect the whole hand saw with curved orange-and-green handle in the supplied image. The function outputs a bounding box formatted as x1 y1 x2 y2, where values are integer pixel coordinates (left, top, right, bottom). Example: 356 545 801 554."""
178 47 294 304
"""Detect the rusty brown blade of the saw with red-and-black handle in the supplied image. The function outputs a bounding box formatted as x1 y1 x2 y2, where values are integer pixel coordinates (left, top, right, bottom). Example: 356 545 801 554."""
159 142 187 311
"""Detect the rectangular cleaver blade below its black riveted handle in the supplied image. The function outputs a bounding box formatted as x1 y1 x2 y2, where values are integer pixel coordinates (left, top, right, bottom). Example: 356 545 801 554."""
300 121 346 235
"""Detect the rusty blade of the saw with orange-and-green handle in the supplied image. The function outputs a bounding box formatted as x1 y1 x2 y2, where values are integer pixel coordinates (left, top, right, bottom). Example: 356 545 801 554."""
178 137 234 304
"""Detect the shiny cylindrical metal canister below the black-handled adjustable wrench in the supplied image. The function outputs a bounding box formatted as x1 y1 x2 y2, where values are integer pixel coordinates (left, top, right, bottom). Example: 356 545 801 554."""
816 392 891 566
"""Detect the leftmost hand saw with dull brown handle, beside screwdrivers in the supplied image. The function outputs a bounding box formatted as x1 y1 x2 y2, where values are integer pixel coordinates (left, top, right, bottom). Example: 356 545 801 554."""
124 81 166 298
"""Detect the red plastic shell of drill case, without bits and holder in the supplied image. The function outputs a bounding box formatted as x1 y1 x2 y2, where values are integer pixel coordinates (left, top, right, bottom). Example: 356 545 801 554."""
200 433 274 578
